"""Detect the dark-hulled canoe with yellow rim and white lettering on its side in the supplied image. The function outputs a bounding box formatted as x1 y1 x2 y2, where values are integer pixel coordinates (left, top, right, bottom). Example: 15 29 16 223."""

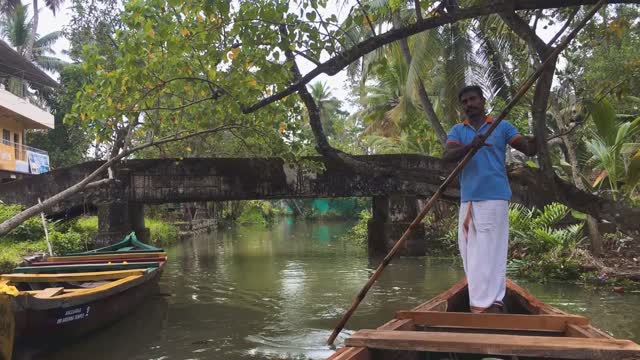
0 262 164 359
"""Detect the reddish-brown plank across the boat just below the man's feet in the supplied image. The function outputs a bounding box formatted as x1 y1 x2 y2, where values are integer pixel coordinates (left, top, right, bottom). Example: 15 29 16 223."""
396 311 589 332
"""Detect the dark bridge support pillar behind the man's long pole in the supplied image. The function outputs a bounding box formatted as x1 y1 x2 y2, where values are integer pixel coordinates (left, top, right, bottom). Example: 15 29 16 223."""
367 195 427 256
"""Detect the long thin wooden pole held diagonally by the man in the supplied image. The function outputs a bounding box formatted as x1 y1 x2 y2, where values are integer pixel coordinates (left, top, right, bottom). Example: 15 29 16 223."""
327 0 607 345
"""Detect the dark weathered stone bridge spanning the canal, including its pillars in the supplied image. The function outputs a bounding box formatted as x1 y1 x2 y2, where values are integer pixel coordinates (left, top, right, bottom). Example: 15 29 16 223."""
0 155 540 255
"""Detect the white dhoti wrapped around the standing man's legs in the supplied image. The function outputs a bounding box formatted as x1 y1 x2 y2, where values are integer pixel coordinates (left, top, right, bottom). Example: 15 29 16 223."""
458 200 509 312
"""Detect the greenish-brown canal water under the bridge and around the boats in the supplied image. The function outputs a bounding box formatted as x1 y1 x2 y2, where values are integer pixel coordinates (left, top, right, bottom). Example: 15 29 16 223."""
42 219 640 360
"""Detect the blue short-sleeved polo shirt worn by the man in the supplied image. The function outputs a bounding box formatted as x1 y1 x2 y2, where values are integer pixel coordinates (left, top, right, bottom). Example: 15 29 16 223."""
447 117 520 202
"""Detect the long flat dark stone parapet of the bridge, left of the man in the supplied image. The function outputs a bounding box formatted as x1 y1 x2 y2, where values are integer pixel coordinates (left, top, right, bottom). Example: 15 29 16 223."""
126 155 457 203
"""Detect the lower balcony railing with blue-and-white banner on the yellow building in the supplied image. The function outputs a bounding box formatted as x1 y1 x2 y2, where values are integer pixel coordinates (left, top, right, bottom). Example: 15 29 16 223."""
0 140 49 174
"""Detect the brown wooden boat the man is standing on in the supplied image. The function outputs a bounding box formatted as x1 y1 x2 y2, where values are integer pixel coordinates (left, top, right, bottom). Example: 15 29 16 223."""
329 280 640 360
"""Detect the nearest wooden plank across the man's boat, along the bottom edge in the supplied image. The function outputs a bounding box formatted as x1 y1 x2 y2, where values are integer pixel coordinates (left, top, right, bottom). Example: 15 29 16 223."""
345 330 640 360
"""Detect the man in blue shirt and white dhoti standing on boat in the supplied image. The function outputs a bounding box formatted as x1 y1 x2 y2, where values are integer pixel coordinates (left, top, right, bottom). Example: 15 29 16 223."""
442 86 537 313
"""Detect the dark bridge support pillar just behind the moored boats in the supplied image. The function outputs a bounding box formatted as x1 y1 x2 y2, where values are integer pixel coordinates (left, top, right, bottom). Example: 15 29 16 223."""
96 200 150 247
